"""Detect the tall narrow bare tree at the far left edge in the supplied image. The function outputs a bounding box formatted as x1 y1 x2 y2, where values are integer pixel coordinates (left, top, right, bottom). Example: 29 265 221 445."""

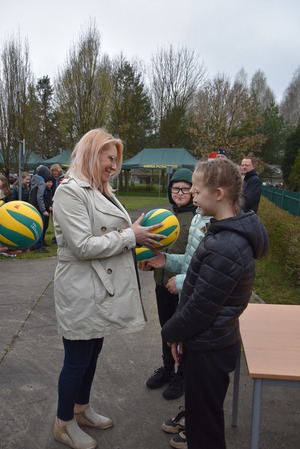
0 33 36 176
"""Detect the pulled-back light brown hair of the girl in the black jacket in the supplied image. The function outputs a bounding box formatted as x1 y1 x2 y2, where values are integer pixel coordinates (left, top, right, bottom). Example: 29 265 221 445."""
194 158 242 214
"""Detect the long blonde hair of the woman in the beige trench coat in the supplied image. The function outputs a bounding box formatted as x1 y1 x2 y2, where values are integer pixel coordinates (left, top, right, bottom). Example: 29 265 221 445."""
66 129 123 196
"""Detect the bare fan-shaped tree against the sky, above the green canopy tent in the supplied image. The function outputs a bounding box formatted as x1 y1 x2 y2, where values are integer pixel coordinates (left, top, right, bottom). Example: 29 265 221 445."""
150 45 205 147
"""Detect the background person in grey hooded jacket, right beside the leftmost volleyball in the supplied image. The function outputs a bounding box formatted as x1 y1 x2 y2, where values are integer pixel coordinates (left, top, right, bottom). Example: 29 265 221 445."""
29 165 50 253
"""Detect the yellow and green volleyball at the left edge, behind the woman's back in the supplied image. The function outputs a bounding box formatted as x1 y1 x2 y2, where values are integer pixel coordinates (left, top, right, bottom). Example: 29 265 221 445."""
0 201 43 250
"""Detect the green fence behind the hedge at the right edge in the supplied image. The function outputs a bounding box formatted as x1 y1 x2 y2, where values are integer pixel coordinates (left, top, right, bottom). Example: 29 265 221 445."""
262 186 300 217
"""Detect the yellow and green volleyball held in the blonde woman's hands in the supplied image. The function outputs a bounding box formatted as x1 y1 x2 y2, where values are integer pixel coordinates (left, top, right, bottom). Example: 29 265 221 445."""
141 209 180 250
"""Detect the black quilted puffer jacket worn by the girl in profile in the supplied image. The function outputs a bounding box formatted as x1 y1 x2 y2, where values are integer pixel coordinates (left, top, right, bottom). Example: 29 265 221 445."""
162 211 269 351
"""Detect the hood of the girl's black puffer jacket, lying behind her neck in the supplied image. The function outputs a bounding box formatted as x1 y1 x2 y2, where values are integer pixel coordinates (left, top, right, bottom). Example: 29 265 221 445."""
209 211 269 259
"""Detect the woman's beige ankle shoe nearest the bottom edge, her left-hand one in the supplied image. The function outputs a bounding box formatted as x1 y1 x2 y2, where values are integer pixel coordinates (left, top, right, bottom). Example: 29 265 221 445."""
54 418 97 449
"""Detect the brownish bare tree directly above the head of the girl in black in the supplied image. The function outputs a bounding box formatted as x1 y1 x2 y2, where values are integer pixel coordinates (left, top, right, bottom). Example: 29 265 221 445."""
191 72 264 162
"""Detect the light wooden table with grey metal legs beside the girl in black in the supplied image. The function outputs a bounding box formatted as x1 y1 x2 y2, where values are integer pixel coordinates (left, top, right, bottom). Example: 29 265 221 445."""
232 304 300 449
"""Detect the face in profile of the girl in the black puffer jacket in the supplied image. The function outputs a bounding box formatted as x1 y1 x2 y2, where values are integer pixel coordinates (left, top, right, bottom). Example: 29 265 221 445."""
191 174 218 217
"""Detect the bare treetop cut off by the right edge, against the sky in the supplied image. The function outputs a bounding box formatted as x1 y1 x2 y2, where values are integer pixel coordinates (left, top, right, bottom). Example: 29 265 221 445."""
280 66 300 127
